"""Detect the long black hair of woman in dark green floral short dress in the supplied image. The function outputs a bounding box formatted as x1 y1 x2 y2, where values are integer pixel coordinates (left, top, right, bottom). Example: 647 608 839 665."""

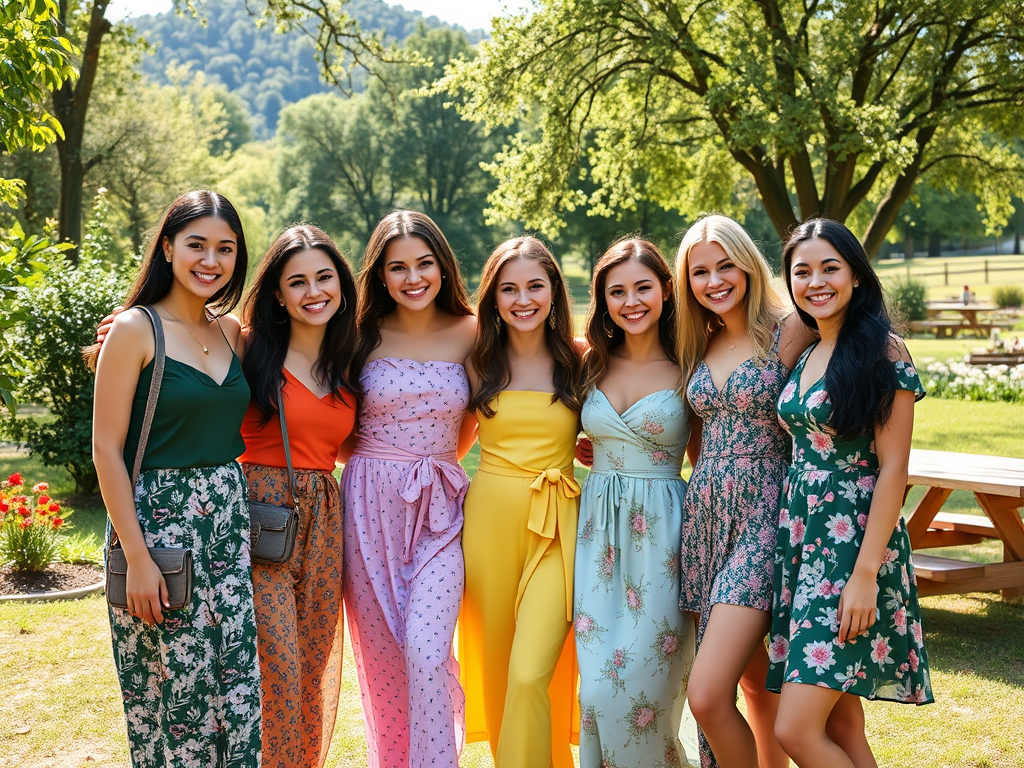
782 219 896 438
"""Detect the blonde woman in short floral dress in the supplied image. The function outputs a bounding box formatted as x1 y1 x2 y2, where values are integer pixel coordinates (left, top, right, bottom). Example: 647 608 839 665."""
676 214 812 768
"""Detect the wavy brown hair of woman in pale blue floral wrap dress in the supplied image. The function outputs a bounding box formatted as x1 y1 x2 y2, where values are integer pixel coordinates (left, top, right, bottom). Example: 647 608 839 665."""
584 238 679 391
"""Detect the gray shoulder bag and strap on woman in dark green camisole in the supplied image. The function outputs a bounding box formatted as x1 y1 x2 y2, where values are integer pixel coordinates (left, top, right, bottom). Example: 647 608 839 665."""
106 306 193 610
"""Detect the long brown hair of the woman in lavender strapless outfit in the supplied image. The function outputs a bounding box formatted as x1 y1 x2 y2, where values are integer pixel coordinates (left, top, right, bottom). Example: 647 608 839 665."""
350 210 473 382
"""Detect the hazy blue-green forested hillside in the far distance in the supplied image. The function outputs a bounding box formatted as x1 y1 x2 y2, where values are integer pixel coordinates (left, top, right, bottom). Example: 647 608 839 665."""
134 0 481 135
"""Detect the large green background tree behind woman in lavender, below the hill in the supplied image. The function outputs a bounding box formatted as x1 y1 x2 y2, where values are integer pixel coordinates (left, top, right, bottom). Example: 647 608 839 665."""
278 28 498 270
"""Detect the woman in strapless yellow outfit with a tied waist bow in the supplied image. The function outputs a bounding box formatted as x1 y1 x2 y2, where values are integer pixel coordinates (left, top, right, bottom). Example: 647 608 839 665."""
459 238 583 768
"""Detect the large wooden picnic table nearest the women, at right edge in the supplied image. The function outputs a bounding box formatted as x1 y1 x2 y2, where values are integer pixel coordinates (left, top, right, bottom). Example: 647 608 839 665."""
906 449 1024 599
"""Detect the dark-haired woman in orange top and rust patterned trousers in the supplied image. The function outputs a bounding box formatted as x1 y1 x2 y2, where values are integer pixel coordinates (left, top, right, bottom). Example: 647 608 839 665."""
239 225 356 768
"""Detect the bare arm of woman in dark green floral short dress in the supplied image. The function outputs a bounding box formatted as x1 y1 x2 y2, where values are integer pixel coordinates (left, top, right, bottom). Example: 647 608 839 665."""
839 389 913 643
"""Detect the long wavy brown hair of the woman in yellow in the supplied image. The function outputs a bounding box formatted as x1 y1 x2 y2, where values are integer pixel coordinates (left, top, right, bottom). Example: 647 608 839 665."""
469 237 583 419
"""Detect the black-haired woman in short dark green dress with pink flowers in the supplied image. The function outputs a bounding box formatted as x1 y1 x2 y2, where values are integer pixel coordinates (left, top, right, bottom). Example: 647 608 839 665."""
768 219 933 768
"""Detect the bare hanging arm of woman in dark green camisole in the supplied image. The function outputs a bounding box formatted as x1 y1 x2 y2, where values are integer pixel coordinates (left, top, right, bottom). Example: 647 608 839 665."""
92 312 167 624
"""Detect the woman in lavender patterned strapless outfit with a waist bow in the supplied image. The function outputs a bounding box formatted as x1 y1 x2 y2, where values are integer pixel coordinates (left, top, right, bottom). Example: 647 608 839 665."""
341 211 476 768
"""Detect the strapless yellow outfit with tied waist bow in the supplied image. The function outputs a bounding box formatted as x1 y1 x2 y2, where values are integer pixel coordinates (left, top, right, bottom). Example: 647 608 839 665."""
458 390 580 768
